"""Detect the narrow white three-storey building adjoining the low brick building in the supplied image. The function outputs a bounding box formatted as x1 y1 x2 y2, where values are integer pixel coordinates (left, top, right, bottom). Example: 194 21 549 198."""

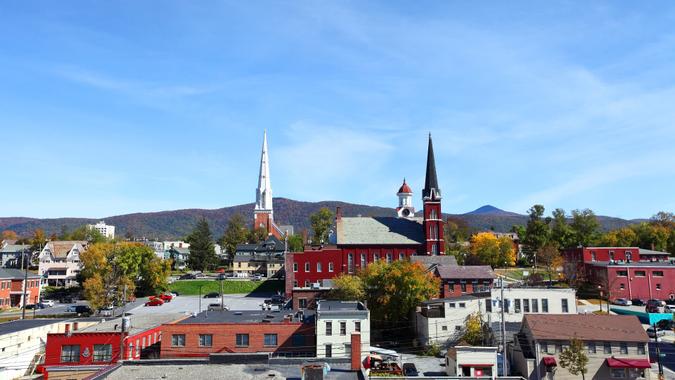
316 301 370 359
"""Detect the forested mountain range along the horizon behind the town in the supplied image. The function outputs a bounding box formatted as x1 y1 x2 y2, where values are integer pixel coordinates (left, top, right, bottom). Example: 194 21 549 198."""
0 198 642 240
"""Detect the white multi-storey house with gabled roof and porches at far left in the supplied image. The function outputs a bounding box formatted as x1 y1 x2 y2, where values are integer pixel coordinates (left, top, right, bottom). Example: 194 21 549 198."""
38 241 88 286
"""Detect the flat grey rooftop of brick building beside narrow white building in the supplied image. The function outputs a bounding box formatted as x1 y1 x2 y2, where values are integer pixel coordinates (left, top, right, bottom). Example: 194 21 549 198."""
178 310 313 324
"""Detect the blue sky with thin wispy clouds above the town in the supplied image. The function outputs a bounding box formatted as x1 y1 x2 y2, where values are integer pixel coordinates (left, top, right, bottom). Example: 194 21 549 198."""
0 1 675 218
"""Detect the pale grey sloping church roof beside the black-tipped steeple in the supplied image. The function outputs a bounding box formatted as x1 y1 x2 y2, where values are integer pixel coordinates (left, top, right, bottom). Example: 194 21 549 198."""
336 217 425 245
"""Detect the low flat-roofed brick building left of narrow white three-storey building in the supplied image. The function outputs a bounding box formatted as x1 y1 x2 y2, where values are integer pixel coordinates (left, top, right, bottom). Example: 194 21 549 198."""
161 310 316 359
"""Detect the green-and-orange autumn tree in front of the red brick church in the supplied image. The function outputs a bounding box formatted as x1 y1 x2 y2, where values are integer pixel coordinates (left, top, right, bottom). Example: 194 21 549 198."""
359 260 440 324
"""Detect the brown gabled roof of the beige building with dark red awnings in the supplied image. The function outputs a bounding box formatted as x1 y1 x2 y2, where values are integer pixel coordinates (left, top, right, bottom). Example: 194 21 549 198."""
523 314 649 343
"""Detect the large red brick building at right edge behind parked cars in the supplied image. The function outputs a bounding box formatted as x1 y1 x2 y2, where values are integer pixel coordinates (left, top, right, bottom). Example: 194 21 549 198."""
563 247 675 301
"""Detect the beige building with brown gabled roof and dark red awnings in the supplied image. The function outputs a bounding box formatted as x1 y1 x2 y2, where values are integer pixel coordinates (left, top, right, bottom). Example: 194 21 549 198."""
508 314 651 380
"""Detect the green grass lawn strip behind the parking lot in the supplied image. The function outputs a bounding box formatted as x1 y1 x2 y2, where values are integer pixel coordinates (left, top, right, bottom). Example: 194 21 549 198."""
169 280 284 295
